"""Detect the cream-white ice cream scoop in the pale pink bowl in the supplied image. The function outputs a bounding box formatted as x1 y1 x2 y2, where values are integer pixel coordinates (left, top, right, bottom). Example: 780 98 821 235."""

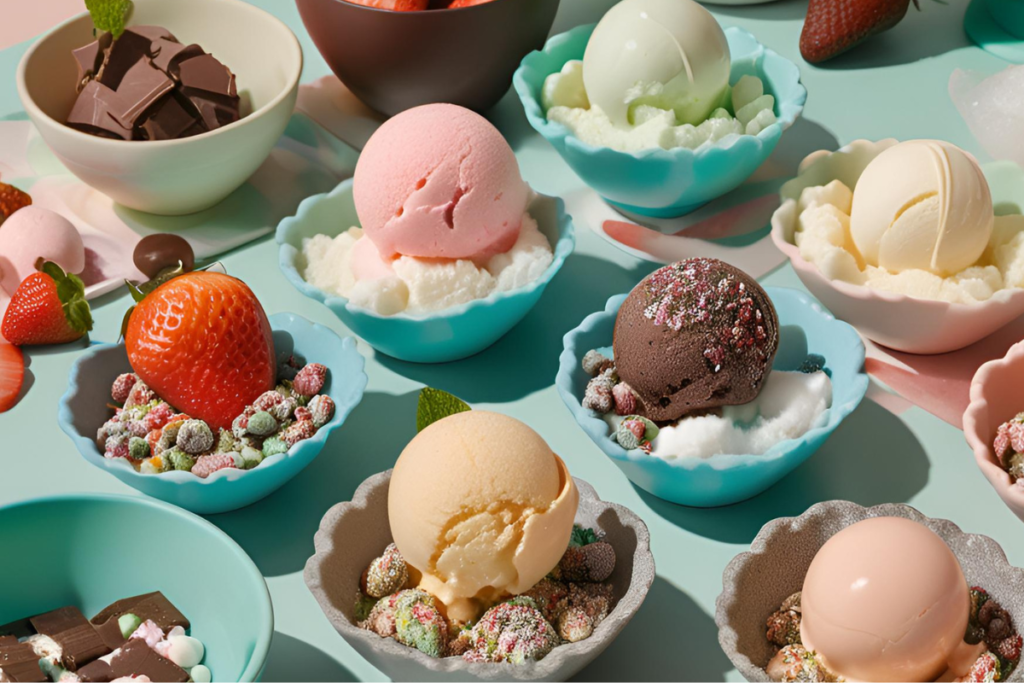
850 140 994 276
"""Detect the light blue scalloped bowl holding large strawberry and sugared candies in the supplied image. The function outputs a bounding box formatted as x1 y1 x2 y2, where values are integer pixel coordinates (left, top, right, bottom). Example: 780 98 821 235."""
57 313 367 516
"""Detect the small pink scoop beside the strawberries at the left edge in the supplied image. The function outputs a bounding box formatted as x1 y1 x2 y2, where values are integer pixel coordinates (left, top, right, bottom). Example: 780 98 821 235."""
0 206 85 295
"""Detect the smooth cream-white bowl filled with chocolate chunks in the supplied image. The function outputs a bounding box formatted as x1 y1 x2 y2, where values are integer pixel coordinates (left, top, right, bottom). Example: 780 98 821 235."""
17 0 302 215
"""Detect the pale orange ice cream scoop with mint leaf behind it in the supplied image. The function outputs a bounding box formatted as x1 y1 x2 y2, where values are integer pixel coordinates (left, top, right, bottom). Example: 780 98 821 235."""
388 411 580 622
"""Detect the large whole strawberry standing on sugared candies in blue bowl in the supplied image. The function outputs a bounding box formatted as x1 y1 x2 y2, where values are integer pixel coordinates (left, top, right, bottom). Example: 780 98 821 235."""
125 271 275 430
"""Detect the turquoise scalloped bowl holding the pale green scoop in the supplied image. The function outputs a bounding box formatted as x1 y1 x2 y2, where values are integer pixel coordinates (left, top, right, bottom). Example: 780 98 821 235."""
512 25 807 218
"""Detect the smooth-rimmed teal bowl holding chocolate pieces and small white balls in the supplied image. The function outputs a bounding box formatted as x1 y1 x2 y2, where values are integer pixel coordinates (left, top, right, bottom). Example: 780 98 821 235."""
0 495 273 681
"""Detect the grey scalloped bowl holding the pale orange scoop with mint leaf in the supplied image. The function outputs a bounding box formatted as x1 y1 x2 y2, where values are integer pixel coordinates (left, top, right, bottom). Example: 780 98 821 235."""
304 470 654 681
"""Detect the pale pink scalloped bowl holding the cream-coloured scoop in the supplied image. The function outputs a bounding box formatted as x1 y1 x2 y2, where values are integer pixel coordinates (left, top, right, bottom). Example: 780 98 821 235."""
771 138 1024 354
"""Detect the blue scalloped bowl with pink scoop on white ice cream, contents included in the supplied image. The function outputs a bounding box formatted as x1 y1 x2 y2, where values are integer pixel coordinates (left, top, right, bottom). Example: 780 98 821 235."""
278 104 574 362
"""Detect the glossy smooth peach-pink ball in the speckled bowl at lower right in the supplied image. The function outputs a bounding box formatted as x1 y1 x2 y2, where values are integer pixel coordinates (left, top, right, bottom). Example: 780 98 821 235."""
800 517 973 681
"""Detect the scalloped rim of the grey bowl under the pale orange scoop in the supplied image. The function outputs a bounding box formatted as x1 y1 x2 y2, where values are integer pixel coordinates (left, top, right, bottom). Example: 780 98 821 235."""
303 469 656 680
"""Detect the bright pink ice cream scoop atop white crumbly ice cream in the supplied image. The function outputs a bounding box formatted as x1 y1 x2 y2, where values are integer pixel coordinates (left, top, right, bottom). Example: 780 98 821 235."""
353 104 529 259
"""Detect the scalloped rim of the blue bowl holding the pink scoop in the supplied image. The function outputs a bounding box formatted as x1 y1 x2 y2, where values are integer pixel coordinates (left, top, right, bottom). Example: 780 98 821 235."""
275 179 575 323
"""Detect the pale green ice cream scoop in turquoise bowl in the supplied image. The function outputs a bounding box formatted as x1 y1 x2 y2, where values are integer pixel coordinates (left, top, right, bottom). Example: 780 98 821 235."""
583 0 730 127
